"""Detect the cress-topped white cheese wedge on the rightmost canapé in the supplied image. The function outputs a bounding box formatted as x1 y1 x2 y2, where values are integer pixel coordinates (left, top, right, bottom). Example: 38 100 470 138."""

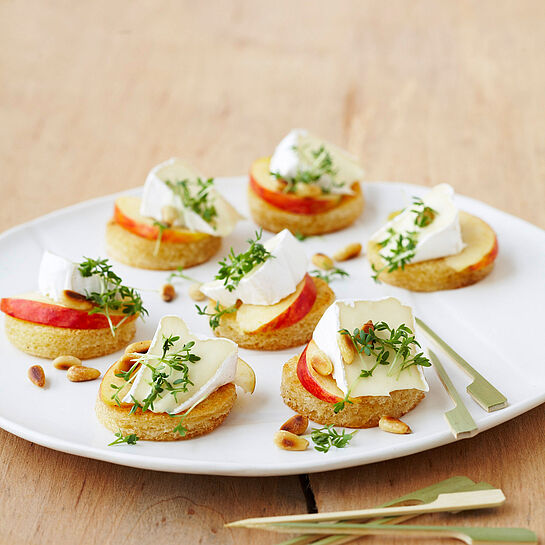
371 184 465 263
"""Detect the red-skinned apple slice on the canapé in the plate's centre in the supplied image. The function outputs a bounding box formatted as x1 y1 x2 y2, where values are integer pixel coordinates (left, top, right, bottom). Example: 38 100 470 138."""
236 273 318 333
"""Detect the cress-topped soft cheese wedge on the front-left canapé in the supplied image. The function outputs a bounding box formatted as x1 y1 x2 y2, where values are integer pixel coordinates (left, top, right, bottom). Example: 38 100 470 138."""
123 316 238 414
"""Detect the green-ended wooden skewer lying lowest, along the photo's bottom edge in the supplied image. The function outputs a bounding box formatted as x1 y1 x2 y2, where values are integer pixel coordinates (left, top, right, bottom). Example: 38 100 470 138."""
262 522 537 545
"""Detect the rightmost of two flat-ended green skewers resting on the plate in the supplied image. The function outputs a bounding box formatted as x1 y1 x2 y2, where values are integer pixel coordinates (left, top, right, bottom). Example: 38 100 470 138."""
415 318 507 412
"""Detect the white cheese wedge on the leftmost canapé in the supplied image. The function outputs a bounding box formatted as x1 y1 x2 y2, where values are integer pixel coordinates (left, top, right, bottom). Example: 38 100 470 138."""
38 251 102 302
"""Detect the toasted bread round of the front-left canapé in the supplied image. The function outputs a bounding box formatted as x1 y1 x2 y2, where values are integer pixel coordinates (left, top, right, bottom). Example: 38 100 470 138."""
95 354 237 441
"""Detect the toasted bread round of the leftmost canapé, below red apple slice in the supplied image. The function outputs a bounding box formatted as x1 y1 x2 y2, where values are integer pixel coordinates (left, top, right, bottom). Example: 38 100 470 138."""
5 315 136 360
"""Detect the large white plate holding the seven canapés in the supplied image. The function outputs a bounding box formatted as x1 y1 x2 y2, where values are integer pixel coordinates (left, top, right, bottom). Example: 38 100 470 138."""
0 177 545 475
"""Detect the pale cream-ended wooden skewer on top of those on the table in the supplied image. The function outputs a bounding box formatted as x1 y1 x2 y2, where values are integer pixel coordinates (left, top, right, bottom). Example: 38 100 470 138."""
226 488 505 528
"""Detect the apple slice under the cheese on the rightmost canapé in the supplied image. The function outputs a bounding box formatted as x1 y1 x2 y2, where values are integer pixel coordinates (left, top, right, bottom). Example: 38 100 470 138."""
445 212 498 272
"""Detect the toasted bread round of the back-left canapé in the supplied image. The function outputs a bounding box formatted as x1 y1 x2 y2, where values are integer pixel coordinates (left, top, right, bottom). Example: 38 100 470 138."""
106 220 221 270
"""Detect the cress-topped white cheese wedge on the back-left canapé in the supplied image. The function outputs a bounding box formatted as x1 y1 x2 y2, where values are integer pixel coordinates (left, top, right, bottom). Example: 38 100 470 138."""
140 158 242 237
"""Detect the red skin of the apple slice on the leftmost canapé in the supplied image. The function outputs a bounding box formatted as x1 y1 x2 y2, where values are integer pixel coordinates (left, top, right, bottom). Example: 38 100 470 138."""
0 297 133 329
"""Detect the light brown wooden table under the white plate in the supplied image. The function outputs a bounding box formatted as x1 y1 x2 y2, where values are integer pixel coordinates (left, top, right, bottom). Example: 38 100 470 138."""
0 0 545 545
